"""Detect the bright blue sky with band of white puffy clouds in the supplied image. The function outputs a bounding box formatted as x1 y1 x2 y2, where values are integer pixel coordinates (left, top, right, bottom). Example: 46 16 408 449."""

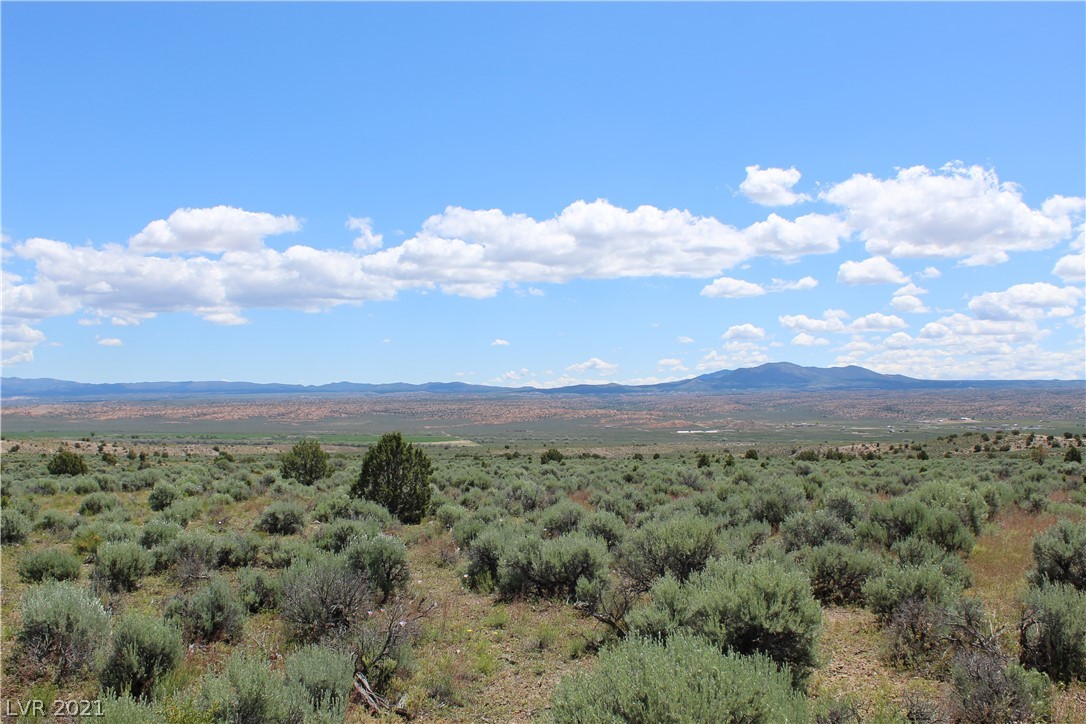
0 2 1086 385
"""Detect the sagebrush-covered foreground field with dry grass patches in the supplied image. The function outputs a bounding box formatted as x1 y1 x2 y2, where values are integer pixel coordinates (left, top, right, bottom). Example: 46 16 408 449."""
2 418 1086 722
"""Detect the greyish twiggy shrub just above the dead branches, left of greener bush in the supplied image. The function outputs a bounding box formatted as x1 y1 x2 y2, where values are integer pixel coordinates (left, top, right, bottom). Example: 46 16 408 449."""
279 556 370 643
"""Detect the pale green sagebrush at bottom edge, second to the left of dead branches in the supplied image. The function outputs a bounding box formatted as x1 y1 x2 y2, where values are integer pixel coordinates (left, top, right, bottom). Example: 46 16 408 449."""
199 650 305 724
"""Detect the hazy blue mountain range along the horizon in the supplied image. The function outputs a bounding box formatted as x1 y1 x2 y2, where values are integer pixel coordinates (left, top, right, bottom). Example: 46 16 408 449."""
0 363 1084 401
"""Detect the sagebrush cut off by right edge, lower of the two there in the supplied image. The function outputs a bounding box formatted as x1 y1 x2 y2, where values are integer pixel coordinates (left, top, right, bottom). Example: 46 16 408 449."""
1019 583 1086 682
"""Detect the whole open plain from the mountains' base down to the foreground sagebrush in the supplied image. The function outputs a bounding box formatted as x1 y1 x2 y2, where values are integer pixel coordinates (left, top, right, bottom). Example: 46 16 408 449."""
0 390 1086 723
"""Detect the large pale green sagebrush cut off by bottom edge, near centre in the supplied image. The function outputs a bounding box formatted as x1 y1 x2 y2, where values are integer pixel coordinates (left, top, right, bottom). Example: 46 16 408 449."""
551 634 807 723
